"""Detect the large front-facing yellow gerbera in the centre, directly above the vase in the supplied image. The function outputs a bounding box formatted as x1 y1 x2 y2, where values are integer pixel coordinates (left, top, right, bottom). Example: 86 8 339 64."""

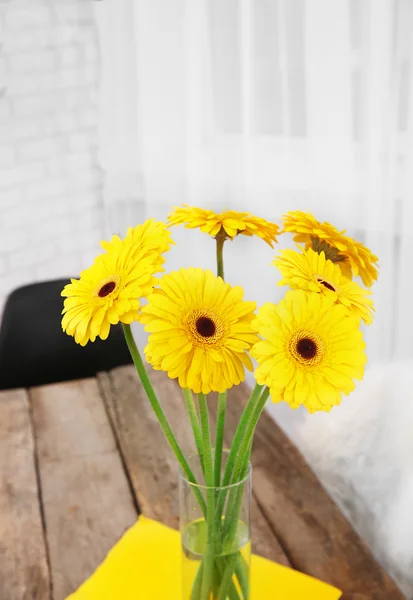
140 268 258 394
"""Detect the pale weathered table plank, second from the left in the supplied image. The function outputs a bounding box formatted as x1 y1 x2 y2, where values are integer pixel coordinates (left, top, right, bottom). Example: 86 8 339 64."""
31 379 136 600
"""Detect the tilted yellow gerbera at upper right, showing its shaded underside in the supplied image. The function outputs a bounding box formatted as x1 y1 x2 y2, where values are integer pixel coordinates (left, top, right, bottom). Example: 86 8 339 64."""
283 210 379 287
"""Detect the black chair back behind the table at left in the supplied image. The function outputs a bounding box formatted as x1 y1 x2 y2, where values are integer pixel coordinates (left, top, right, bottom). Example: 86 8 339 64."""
0 279 132 390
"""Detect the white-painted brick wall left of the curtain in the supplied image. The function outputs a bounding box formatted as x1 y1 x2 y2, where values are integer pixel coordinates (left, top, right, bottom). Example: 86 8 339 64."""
0 0 102 313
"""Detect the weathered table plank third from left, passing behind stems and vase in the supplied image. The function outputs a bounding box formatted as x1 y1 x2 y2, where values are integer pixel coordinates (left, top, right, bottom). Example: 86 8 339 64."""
99 366 288 564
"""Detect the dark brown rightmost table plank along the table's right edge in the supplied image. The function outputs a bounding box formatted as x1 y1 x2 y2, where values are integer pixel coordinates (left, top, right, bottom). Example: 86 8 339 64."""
224 386 403 600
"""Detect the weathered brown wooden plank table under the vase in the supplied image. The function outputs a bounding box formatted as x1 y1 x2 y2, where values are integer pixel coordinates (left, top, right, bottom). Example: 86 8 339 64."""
0 367 403 600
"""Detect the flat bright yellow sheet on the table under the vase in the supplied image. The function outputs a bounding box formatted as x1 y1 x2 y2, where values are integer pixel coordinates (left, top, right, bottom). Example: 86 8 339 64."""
67 516 341 600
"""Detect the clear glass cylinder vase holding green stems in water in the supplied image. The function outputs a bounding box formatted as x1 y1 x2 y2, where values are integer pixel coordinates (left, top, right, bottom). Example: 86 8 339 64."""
179 451 251 600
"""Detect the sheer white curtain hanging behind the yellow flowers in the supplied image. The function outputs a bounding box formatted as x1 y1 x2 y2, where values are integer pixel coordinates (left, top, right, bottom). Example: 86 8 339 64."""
96 0 413 378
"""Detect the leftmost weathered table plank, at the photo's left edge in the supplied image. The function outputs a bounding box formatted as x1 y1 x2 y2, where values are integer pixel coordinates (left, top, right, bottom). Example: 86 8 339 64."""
0 390 50 600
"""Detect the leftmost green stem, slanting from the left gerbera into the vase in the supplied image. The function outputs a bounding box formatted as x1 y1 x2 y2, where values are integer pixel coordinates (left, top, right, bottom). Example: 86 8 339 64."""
122 324 206 514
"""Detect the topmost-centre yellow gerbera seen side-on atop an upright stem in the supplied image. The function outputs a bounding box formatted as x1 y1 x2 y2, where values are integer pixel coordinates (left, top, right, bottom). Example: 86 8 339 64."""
168 205 279 248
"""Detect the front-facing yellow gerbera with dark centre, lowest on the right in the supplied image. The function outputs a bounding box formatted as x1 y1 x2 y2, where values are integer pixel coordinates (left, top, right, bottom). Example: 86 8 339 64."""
251 290 366 412
